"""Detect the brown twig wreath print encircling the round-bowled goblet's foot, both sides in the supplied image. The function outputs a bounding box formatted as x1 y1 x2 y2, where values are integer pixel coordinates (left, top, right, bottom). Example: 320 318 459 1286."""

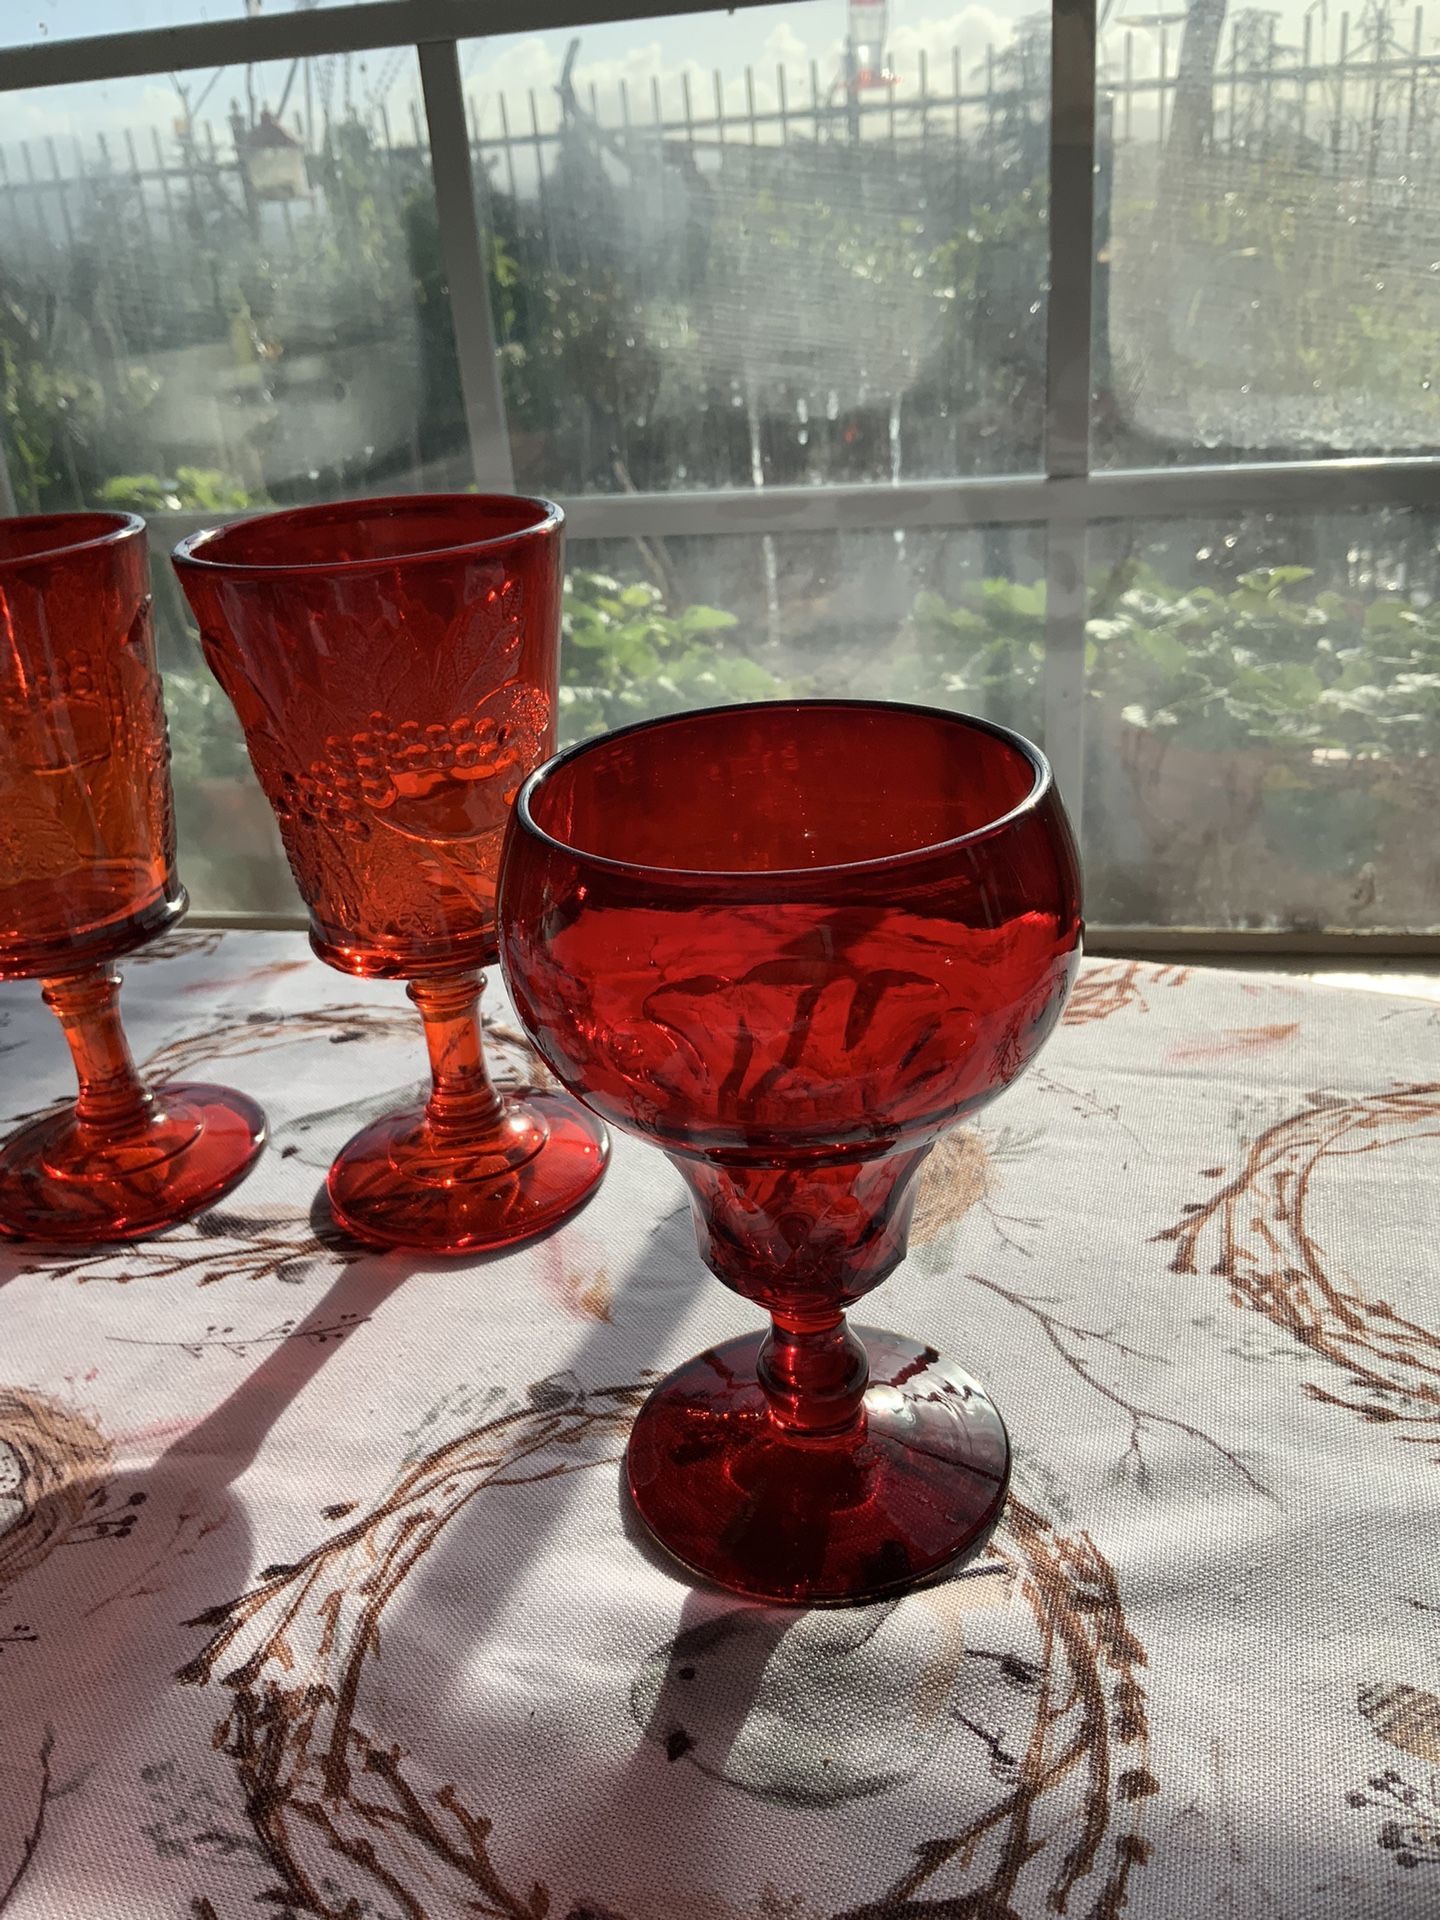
180 1377 1158 1920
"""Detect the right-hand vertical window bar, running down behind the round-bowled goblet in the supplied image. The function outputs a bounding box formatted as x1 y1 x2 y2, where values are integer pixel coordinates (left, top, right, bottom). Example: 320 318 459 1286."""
1044 0 1094 837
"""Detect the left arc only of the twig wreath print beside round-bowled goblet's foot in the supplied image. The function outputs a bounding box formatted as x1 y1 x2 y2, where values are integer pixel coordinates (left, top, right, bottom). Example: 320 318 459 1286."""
180 1379 647 1920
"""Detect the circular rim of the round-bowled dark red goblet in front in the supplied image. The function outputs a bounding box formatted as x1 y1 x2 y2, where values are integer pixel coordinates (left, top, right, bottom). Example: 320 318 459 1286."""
513 697 1054 887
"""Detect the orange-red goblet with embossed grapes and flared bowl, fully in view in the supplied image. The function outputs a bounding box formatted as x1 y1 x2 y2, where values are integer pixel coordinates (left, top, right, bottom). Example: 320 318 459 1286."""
175 493 609 1254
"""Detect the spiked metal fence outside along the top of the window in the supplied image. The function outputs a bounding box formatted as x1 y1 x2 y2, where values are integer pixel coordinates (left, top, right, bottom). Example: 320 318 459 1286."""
0 6 1440 257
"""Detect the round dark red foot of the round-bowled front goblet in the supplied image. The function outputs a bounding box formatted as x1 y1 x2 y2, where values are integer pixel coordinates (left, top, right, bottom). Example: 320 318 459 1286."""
626 1327 1010 1607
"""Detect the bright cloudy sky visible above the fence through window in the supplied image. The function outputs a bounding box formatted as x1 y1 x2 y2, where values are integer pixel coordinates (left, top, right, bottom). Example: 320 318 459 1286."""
0 0 1413 165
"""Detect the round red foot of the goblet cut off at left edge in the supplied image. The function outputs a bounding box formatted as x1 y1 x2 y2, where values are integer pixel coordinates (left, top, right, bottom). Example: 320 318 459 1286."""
0 1083 265 1246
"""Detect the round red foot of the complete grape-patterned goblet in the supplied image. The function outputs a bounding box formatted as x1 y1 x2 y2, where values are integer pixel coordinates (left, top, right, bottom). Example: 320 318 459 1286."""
326 1092 611 1254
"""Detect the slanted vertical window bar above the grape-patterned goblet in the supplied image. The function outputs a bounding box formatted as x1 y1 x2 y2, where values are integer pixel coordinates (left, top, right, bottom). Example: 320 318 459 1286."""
417 40 515 493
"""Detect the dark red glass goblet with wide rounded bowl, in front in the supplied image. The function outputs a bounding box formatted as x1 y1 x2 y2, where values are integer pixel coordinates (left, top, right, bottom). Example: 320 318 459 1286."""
501 701 1081 1603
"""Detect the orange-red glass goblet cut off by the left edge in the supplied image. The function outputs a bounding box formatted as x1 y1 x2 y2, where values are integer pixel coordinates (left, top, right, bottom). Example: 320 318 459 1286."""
0 513 265 1244
